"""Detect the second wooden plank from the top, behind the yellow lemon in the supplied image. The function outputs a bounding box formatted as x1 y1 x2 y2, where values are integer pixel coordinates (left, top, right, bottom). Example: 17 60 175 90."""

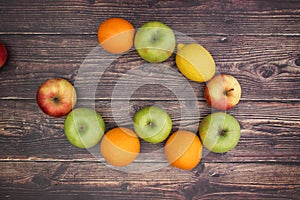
0 35 300 100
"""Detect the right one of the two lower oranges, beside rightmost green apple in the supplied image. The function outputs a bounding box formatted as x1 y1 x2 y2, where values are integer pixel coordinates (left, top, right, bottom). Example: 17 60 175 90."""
165 130 202 170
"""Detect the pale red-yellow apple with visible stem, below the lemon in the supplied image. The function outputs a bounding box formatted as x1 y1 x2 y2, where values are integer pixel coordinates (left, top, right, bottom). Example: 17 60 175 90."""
204 74 242 110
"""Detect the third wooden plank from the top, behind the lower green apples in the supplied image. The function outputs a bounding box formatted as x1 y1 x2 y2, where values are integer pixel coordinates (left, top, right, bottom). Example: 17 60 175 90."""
0 100 300 165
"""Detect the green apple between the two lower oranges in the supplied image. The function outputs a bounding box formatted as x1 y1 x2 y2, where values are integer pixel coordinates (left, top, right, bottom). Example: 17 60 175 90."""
133 106 172 144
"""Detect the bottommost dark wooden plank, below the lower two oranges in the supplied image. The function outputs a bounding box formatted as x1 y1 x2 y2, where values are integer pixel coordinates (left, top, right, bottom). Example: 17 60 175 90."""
0 162 300 199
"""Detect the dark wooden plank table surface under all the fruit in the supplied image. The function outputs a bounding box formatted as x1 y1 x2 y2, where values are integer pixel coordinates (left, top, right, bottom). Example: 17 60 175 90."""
0 0 300 199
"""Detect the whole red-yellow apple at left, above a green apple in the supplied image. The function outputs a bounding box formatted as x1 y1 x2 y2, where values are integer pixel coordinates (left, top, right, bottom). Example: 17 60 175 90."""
36 78 76 117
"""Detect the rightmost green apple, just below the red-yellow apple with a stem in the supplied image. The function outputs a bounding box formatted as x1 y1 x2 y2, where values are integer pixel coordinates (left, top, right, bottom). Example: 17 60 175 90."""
199 112 241 153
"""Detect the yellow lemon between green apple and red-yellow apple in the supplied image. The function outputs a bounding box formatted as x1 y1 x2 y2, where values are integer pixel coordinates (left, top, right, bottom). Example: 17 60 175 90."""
176 43 216 82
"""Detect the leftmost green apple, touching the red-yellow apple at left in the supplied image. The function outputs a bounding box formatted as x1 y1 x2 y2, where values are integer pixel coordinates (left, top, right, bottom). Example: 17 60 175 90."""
64 108 105 148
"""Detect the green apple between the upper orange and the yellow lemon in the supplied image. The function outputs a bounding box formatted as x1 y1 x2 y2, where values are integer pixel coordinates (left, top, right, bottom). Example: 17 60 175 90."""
134 21 176 63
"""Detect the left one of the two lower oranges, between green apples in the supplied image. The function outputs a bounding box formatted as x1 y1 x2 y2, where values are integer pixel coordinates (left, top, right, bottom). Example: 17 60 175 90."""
100 128 140 166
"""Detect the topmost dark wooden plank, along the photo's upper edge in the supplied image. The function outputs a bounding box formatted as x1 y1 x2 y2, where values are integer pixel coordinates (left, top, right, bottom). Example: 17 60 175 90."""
0 0 300 35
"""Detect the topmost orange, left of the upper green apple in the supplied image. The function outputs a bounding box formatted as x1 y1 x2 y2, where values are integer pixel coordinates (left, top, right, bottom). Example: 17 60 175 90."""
98 18 134 53
